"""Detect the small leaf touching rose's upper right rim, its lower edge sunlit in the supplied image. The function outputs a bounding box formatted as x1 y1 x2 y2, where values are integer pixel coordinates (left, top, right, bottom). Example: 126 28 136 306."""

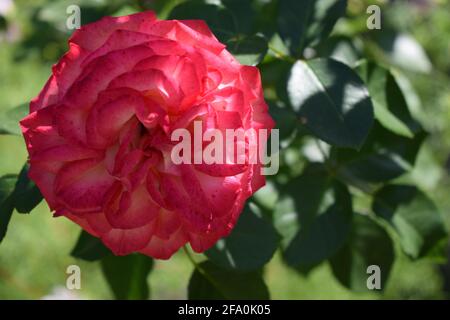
226 35 268 66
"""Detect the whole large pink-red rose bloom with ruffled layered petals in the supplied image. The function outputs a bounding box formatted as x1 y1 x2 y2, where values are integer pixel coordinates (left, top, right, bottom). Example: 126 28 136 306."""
20 12 274 259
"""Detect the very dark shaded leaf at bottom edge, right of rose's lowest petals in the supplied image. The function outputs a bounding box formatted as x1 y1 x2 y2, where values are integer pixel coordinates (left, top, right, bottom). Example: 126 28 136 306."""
188 261 269 300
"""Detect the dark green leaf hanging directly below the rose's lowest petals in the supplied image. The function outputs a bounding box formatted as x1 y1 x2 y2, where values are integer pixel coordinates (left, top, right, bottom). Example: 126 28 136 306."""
101 254 153 300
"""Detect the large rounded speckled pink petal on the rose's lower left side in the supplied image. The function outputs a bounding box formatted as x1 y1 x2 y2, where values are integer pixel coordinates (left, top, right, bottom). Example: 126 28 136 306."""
55 159 114 213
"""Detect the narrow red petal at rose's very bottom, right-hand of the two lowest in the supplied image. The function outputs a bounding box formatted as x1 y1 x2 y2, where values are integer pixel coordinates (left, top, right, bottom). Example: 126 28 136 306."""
139 228 188 260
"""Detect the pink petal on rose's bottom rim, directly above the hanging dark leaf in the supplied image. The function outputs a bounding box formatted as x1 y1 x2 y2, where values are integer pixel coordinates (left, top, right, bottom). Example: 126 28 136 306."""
101 222 155 256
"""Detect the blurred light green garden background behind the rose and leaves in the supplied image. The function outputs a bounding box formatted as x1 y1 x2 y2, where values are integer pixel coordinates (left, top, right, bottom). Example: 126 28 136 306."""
0 0 450 299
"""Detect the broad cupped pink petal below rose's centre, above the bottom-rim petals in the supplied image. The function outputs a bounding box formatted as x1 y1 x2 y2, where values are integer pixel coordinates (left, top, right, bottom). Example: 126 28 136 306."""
105 181 161 229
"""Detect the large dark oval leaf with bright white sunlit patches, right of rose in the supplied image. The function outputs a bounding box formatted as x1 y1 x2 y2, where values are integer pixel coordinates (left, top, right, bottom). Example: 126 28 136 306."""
287 59 373 149
